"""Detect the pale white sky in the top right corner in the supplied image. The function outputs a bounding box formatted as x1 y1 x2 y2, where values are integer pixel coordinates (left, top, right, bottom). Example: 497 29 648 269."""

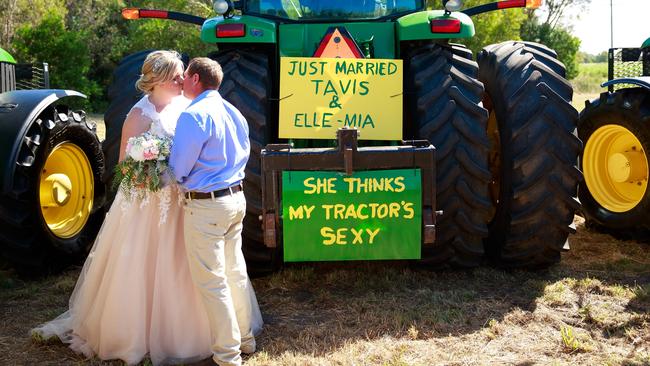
564 0 650 54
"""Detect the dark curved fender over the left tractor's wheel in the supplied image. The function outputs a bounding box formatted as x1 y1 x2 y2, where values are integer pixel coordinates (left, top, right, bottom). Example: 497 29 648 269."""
0 89 86 194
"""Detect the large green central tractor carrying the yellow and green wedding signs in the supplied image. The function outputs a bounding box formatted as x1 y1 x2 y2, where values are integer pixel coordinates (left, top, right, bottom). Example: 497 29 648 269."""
109 0 582 271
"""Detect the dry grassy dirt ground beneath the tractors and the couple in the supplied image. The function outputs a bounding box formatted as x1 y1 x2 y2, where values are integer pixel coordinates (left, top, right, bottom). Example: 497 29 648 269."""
0 217 650 365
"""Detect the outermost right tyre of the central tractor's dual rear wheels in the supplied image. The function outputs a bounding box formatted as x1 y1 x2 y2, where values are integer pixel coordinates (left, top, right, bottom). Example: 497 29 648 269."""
478 42 582 269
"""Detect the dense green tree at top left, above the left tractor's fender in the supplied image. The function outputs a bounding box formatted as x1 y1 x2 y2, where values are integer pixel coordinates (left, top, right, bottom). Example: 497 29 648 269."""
13 13 101 107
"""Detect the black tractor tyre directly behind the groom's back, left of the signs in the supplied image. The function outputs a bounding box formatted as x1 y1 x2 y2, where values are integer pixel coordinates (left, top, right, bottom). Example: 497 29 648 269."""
209 49 282 275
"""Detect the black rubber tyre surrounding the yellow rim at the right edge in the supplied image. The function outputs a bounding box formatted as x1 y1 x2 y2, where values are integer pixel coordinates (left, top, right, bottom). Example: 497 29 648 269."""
578 88 650 240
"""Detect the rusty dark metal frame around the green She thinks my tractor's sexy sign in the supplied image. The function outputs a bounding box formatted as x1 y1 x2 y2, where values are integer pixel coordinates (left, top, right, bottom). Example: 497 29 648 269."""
260 128 437 252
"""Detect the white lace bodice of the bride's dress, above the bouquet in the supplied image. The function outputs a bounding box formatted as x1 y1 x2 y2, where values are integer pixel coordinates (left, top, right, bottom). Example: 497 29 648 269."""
131 95 190 136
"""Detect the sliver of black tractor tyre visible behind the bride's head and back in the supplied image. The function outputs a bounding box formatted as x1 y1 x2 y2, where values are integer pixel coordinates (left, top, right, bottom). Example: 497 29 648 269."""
102 50 153 197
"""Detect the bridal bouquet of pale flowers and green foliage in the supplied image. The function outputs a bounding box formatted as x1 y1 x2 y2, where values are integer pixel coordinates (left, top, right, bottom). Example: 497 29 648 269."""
113 132 172 197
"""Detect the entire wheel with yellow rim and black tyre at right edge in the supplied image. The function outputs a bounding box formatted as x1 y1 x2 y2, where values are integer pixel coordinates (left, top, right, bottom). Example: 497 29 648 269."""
578 88 650 239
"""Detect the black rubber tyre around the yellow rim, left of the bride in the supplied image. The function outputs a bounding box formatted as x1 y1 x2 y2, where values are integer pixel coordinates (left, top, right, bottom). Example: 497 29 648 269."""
0 105 105 275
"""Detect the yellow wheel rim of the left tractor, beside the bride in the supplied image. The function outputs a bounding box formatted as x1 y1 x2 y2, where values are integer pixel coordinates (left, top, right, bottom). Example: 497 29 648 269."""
39 142 95 239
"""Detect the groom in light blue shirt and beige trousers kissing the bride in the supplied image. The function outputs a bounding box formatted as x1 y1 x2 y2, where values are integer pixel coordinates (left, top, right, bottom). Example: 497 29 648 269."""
169 57 255 365
